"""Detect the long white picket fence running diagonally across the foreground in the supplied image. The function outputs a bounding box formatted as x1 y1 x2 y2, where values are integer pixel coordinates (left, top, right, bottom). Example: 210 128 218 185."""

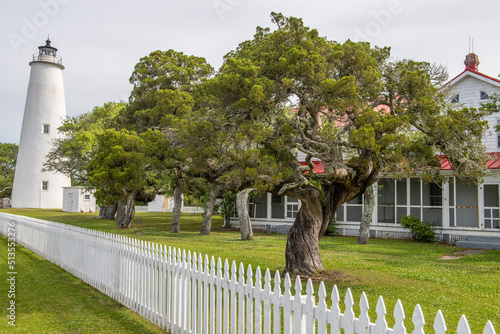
0 213 495 334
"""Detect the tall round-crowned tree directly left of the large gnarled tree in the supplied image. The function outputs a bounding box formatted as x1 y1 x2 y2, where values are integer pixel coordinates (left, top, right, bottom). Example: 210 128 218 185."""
121 50 213 233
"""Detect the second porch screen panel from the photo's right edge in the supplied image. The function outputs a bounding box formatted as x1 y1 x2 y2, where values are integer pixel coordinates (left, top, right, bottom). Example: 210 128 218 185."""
455 180 479 227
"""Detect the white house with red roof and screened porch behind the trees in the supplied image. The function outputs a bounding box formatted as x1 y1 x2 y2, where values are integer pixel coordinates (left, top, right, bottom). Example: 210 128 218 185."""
233 54 500 243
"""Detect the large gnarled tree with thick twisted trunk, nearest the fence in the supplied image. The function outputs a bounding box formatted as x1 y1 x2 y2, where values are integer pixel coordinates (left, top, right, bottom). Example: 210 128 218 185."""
207 13 488 274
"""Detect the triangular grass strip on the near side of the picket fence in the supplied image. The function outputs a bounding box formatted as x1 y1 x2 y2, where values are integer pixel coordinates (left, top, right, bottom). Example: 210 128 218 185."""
0 235 163 333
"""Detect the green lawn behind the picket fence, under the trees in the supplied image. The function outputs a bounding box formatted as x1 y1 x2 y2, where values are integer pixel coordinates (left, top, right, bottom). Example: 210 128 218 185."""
2 209 500 333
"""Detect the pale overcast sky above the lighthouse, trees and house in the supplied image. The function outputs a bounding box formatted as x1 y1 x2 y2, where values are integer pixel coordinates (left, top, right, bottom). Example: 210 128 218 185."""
0 0 500 143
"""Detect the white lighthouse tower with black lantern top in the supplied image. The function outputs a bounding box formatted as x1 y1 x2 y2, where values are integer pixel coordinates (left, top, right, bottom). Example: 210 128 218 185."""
12 39 71 209
